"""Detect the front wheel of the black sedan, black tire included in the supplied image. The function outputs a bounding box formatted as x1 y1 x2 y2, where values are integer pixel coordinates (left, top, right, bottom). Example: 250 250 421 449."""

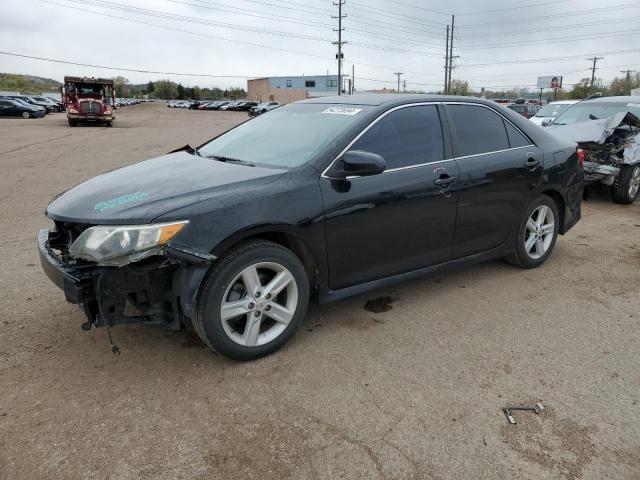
193 240 309 360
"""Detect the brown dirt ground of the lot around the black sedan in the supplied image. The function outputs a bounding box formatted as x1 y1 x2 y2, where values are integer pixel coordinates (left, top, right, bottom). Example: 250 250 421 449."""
0 104 640 480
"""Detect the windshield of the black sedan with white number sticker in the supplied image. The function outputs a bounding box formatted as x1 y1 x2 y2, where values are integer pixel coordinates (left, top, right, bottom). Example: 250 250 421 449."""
198 103 367 167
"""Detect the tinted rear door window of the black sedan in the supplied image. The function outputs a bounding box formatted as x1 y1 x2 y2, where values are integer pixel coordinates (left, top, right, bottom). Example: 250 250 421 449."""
447 105 509 157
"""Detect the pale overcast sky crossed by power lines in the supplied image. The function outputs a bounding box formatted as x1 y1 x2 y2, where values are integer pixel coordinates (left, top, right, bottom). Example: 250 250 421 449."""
0 0 640 91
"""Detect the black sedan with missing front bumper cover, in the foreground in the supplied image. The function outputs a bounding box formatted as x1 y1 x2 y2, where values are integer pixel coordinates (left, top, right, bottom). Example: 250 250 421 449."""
38 95 583 360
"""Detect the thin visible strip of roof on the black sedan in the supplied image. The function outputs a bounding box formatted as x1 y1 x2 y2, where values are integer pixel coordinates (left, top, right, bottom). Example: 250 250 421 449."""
296 93 496 107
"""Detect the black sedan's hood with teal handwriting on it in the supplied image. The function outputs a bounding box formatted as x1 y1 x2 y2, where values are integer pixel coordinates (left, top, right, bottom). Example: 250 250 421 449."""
46 151 286 224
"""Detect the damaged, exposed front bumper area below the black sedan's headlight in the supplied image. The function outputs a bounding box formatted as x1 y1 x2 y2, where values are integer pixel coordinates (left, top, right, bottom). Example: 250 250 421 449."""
38 229 215 330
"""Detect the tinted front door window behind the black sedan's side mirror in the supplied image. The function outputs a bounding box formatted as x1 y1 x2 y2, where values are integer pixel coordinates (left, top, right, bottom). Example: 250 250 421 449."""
350 105 444 170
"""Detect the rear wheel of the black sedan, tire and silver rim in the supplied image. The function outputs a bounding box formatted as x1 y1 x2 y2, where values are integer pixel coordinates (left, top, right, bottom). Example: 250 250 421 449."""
505 195 560 268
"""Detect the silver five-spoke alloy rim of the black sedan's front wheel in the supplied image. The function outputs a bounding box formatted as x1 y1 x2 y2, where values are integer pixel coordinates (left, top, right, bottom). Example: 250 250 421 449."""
220 262 298 347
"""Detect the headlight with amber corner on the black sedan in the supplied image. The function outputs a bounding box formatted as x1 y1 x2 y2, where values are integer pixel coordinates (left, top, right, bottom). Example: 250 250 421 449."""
69 220 189 266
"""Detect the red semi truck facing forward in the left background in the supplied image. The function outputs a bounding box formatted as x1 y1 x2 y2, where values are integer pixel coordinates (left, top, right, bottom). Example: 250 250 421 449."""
62 77 116 127
